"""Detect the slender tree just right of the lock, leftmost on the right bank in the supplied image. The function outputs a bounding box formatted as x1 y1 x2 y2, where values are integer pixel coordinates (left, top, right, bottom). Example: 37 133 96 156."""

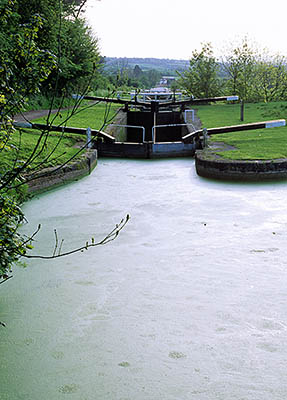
178 43 220 98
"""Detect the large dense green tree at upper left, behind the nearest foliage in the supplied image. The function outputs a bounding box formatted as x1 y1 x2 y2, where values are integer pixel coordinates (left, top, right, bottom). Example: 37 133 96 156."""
7 0 100 96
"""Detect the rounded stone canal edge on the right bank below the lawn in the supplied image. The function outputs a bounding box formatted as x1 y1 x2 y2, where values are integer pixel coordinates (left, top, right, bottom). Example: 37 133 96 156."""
195 144 287 182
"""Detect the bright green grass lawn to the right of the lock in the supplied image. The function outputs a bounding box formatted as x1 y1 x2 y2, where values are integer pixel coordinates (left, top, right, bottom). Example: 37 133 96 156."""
196 102 287 160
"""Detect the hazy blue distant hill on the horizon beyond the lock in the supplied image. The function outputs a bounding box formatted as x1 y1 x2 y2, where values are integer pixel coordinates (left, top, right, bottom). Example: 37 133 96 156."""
104 57 189 75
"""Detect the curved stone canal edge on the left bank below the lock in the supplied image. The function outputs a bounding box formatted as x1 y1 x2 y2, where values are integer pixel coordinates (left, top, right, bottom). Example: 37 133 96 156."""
27 150 98 195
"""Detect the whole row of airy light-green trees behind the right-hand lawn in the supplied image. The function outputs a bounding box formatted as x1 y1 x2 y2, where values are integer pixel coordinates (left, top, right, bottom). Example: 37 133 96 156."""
178 37 287 102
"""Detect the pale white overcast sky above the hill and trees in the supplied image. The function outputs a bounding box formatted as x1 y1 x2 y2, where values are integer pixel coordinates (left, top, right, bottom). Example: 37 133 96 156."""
86 0 287 60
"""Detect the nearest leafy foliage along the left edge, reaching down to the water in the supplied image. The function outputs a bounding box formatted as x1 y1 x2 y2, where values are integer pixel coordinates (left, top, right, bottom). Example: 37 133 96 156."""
0 0 55 282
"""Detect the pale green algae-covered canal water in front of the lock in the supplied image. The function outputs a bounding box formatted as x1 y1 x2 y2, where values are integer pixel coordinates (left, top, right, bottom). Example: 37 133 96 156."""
0 159 287 400
